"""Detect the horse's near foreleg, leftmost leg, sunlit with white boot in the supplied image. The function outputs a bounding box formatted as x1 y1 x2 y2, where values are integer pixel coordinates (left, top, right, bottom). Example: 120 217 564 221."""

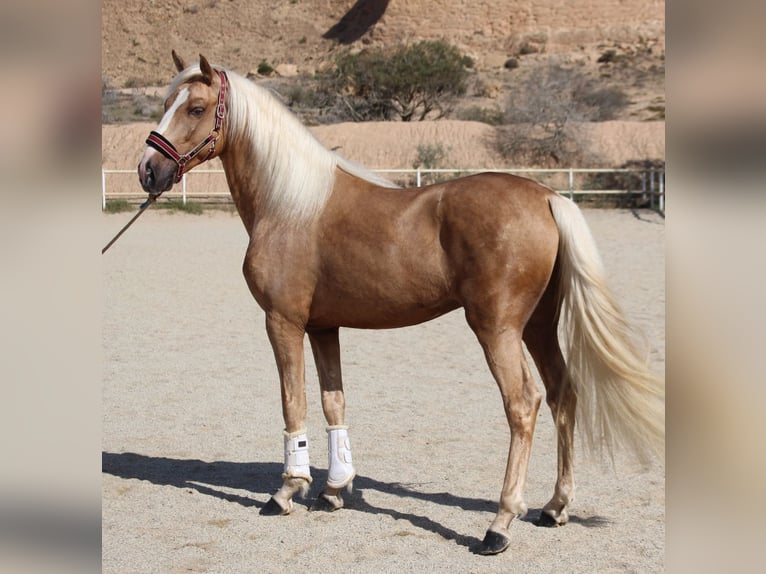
261 313 311 515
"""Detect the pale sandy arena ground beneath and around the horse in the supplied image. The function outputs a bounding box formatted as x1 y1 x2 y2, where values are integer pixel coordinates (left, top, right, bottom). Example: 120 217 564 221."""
102 210 665 574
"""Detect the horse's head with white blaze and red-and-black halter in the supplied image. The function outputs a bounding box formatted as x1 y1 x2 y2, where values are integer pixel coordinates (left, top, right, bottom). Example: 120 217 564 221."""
138 52 228 195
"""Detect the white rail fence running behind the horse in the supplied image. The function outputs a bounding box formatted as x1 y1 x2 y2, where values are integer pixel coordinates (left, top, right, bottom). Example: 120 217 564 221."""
101 168 665 212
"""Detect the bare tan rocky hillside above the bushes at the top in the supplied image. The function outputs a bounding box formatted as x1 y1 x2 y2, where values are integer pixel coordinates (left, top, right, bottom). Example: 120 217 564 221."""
101 0 665 87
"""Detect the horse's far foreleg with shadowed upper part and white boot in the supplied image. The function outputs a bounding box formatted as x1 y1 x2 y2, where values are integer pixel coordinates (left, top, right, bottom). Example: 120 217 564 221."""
309 329 356 510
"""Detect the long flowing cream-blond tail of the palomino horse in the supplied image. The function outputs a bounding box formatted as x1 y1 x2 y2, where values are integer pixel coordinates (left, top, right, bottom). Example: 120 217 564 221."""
550 196 665 461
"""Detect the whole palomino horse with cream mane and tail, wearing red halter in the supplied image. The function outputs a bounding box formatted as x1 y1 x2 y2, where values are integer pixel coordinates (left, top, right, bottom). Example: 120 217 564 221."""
138 53 665 554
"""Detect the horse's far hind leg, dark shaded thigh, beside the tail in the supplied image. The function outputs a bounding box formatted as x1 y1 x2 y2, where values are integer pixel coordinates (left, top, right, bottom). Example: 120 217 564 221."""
524 281 577 526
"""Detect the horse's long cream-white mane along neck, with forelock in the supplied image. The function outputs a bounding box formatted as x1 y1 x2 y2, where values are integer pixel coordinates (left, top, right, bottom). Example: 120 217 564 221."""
168 65 398 220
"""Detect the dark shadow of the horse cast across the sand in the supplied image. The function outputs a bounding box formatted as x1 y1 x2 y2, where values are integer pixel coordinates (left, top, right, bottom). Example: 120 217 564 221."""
101 452 609 551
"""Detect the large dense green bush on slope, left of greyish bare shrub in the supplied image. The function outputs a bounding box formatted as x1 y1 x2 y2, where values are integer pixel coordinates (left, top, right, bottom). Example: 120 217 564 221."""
330 40 472 122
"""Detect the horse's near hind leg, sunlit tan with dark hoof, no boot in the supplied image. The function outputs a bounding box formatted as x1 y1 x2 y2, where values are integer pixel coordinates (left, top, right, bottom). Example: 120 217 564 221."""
477 329 541 554
